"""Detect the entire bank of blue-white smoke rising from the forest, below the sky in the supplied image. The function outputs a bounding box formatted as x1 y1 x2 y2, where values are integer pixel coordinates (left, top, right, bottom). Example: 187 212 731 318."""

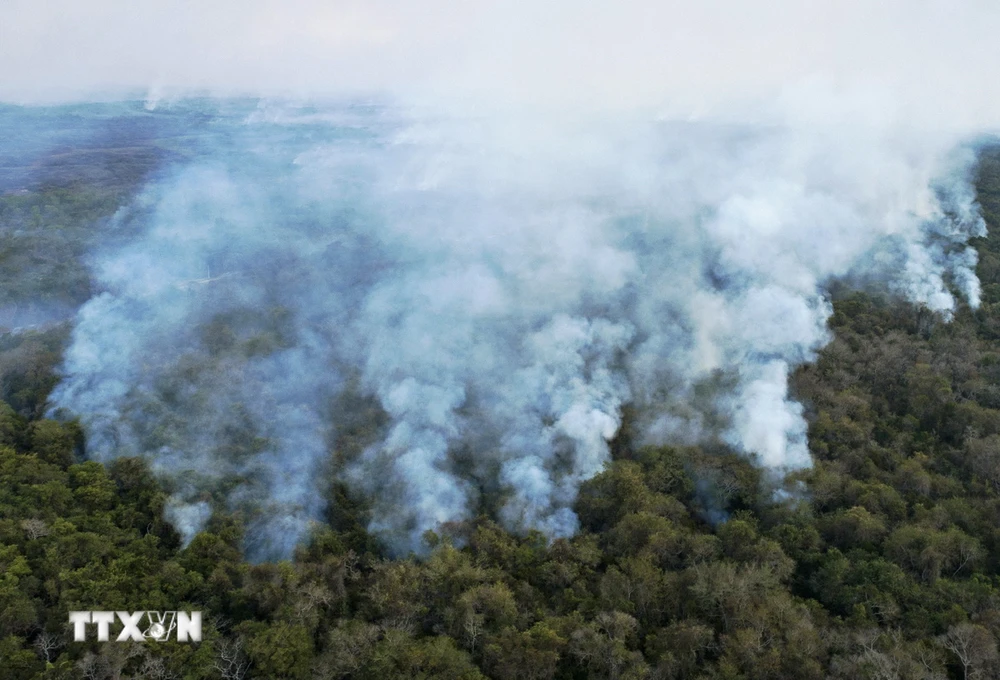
52 105 984 557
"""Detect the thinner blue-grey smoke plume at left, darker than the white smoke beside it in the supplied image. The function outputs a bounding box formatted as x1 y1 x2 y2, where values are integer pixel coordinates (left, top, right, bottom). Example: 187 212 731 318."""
52 107 390 557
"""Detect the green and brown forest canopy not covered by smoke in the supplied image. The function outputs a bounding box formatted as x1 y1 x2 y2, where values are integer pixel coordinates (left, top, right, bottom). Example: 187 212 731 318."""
0 145 1000 680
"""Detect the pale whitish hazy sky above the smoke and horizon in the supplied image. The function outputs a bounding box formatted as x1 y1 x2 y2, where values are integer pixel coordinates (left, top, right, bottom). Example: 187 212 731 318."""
0 0 1000 128
